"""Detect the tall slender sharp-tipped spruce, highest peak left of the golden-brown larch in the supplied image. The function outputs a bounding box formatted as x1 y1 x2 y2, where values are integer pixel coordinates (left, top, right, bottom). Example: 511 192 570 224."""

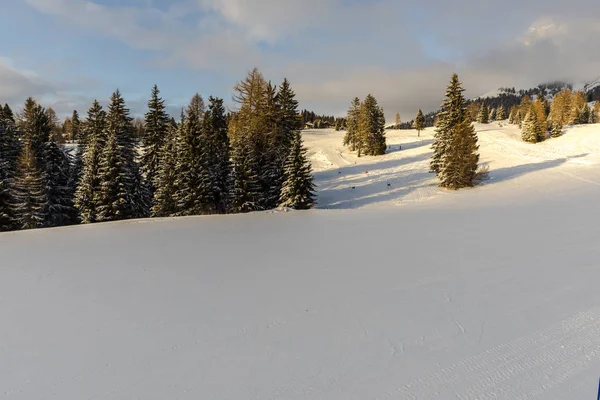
142 85 171 196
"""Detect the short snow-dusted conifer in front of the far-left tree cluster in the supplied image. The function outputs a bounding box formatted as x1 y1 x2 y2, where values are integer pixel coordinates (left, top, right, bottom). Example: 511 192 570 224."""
13 141 44 229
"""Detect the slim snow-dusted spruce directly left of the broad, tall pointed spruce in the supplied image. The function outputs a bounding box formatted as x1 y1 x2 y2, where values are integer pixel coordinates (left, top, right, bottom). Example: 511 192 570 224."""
75 100 106 224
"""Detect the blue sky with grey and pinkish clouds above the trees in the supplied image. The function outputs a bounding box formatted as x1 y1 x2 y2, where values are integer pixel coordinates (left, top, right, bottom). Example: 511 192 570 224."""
0 0 600 121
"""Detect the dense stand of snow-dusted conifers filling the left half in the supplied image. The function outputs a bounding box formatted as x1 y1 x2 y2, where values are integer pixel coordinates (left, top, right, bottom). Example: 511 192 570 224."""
0 69 315 231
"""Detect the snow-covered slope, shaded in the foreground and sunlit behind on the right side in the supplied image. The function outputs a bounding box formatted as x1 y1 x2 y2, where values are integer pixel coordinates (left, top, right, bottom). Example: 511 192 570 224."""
0 123 600 400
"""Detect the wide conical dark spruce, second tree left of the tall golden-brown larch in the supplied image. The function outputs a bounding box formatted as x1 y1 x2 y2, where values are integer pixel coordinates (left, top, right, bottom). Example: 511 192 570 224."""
173 93 214 216
